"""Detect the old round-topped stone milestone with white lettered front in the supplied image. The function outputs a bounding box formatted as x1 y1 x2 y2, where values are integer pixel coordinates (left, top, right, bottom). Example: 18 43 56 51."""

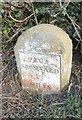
14 24 72 93
